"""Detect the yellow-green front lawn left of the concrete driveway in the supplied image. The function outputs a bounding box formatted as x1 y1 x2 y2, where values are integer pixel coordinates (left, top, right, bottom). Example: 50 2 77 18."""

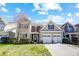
0 44 51 56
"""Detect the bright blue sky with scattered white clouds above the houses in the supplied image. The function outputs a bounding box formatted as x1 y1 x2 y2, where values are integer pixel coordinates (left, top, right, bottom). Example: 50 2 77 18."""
0 3 79 24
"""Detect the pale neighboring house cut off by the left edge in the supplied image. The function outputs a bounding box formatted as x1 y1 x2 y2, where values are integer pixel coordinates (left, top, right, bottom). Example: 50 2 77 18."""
0 17 15 42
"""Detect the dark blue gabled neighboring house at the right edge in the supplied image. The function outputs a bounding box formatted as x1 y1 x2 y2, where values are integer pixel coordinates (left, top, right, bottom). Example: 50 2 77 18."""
62 22 79 39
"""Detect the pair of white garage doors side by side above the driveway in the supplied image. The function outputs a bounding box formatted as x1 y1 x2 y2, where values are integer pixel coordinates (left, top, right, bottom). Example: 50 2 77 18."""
42 34 62 44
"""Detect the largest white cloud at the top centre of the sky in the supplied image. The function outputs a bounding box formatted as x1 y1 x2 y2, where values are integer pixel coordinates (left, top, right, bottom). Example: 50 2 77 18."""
32 3 62 14
